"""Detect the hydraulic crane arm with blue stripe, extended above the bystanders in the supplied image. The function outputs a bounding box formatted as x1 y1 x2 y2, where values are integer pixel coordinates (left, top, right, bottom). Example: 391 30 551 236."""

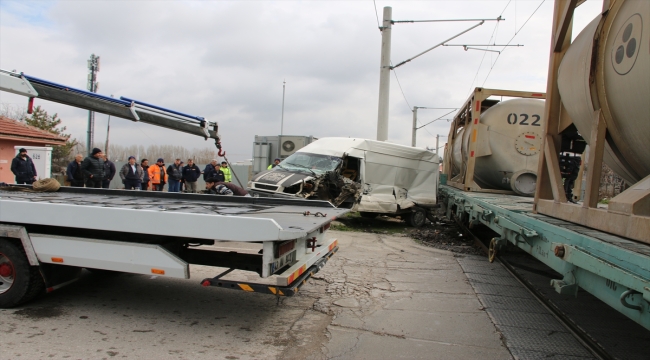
0 69 223 144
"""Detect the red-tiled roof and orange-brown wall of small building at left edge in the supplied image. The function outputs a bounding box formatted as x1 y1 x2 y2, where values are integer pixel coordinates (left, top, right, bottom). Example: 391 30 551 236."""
0 116 67 183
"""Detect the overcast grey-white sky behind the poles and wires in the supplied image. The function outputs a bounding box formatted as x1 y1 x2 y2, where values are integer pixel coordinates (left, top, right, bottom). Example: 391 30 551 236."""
0 0 602 161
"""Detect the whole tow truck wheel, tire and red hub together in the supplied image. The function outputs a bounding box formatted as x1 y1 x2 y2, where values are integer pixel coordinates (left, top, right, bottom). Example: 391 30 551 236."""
0 239 45 308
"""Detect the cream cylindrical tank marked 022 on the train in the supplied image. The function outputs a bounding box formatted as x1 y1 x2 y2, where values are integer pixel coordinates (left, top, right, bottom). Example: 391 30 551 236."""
453 99 544 196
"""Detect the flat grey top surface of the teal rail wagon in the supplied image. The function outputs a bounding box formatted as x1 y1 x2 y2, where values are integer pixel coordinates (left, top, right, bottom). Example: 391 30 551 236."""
441 185 650 256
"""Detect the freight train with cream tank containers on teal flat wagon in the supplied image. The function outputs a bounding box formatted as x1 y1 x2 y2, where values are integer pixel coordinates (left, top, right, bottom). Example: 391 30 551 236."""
438 0 650 329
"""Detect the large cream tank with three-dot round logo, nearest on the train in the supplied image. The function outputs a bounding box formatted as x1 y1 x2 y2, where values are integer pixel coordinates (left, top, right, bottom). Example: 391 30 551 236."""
558 1 650 184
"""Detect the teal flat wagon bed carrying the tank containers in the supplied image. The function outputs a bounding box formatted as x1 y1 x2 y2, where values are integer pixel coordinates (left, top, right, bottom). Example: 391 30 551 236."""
440 185 650 329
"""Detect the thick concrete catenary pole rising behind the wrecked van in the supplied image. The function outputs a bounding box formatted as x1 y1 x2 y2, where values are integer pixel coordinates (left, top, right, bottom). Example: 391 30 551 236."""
377 6 393 141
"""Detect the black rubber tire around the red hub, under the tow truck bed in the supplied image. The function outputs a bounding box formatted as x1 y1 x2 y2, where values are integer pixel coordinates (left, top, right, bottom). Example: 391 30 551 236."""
0 239 45 308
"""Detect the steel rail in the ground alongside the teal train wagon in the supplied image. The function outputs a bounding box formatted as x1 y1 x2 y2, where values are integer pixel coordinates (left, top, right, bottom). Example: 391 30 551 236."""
452 215 615 360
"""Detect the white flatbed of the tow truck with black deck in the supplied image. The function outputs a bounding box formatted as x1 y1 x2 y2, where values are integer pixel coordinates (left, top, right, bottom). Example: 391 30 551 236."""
0 186 349 306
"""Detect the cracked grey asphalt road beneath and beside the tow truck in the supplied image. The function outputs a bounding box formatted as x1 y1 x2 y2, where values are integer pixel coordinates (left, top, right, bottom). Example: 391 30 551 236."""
0 231 511 359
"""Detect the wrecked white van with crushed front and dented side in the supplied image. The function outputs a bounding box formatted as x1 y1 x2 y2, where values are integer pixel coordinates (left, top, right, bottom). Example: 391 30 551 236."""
249 138 440 219
